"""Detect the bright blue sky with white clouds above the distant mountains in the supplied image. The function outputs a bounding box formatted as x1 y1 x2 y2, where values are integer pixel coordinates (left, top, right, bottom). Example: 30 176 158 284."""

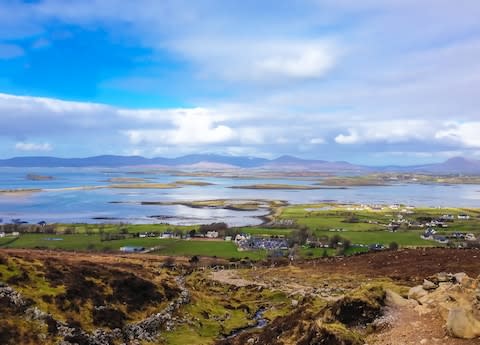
0 0 480 164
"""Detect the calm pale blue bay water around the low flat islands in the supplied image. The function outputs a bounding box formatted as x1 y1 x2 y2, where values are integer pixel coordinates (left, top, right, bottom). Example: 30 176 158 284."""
0 168 480 226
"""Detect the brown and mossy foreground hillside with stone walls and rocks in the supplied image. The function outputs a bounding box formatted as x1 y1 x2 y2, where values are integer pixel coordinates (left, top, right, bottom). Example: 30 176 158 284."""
0 249 480 345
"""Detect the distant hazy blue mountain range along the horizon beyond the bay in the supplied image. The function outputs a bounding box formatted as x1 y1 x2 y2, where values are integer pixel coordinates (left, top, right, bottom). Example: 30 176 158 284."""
0 154 480 175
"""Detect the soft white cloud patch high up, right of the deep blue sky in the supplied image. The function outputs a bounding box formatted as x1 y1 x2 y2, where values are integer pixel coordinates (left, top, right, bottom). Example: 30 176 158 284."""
172 38 340 82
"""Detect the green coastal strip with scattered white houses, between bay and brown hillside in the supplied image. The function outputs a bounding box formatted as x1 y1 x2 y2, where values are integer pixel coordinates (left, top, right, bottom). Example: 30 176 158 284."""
0 203 480 256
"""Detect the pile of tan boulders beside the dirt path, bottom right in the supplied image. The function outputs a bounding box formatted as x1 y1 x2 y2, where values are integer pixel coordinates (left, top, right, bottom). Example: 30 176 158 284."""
408 273 480 339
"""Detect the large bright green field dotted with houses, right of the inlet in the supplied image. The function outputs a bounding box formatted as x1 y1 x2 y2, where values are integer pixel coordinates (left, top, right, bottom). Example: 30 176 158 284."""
279 203 480 247
